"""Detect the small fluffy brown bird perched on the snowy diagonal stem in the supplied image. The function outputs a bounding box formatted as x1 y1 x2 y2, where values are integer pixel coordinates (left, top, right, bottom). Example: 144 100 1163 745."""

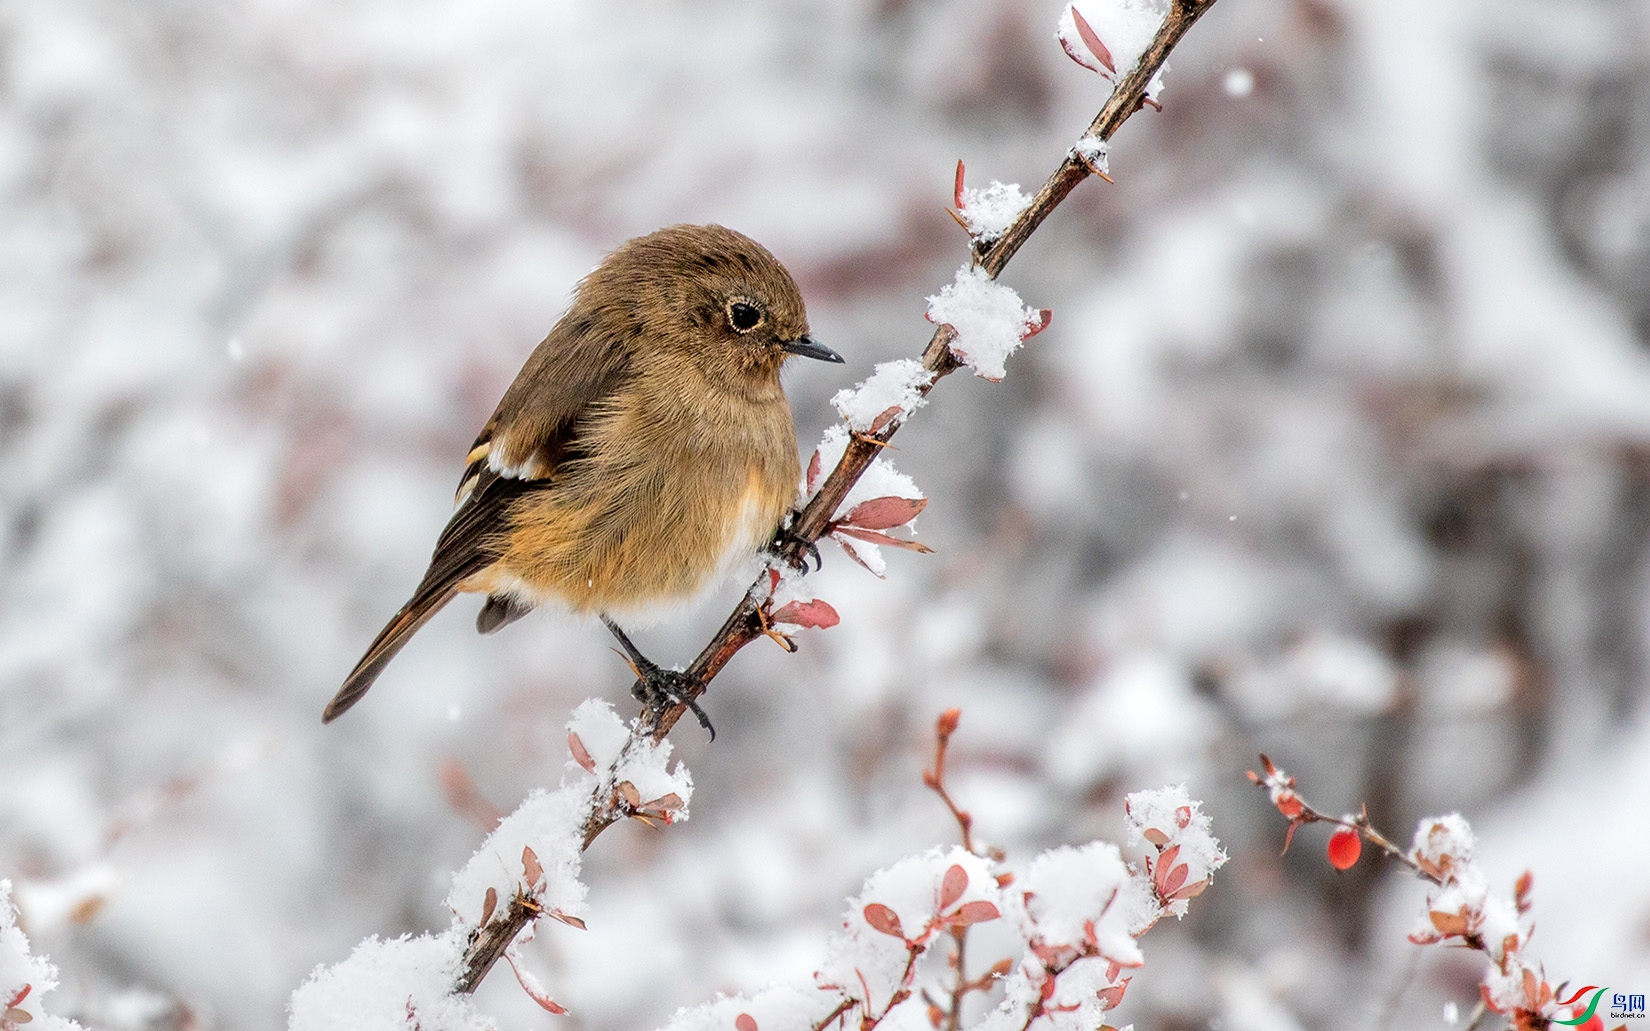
322 226 842 726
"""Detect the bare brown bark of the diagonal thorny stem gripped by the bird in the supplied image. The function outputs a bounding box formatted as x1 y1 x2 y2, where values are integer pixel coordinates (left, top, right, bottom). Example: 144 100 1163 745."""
455 0 1214 993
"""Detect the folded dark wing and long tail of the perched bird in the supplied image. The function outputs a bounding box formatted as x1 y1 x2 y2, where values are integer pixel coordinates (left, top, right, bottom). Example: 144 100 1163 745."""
322 324 629 723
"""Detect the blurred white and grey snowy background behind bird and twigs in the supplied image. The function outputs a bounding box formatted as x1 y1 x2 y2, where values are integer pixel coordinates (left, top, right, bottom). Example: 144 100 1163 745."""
0 0 1650 1031
